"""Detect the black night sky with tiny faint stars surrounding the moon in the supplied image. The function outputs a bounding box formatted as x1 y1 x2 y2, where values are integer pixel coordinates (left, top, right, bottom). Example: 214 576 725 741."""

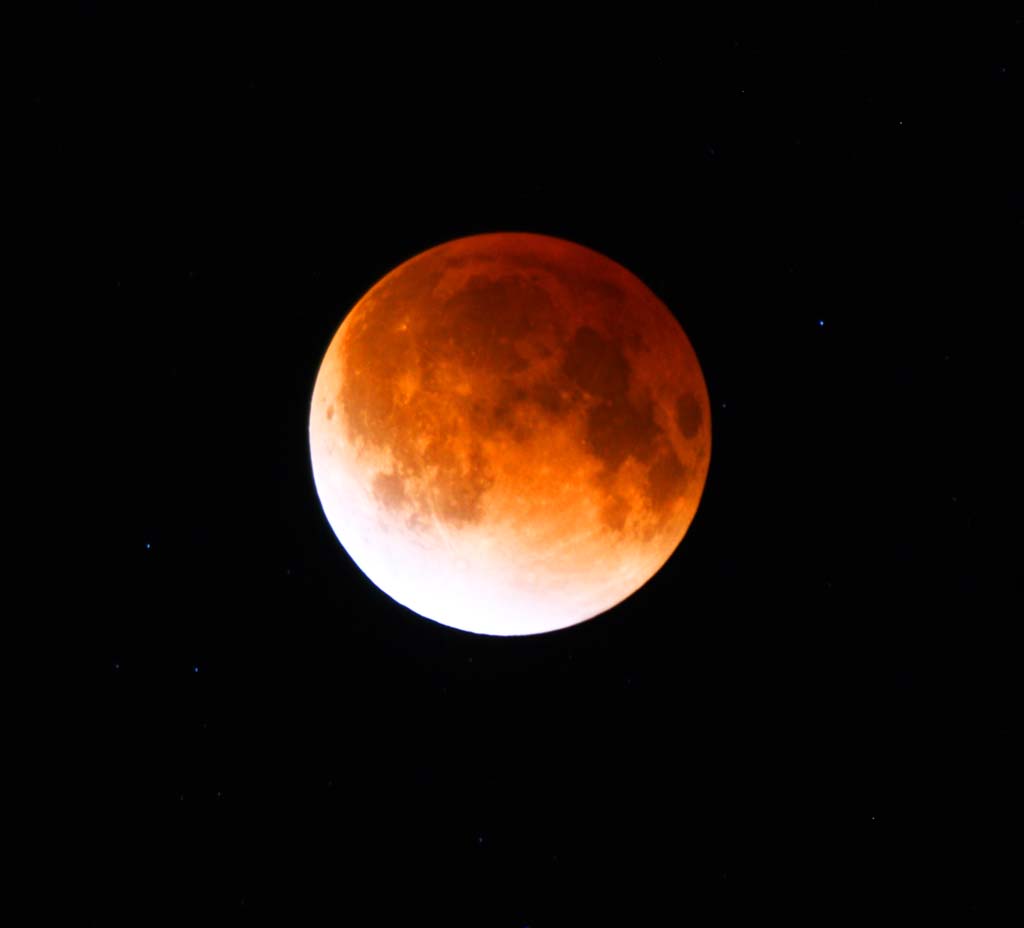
36 4 1024 928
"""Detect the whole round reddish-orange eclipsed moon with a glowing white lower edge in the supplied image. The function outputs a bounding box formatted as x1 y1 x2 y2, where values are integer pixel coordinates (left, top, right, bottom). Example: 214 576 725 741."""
309 233 711 635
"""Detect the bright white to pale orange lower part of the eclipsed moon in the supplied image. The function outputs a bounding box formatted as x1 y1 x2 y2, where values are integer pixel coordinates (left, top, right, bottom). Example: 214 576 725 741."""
310 411 681 636
